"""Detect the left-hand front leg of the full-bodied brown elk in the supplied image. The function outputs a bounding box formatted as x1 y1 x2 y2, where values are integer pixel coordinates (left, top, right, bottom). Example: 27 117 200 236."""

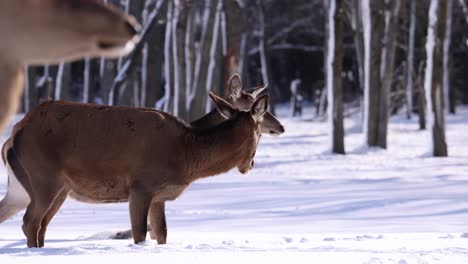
129 190 153 244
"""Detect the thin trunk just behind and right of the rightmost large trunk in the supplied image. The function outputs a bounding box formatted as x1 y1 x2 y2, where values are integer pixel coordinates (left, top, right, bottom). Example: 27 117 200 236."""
443 0 455 114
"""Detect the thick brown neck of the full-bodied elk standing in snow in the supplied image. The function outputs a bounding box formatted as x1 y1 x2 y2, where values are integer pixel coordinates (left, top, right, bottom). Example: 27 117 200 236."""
186 112 260 181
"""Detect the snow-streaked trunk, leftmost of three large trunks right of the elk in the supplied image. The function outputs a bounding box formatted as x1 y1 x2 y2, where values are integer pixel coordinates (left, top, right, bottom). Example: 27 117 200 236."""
327 0 345 154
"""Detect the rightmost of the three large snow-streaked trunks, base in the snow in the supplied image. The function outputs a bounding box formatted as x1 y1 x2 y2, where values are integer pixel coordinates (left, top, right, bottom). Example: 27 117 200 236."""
424 0 448 157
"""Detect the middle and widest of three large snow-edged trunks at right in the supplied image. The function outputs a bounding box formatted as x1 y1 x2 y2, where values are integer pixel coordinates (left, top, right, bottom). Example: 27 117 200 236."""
362 0 386 148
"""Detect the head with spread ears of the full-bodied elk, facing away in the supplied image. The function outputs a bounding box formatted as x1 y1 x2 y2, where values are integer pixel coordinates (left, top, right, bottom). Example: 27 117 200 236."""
210 93 269 174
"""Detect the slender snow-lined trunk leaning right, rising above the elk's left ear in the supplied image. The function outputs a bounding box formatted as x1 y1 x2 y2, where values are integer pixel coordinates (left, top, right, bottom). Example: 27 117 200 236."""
205 0 223 112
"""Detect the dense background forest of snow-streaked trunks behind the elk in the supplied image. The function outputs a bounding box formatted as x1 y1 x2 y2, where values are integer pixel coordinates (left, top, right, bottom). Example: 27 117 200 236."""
23 0 468 156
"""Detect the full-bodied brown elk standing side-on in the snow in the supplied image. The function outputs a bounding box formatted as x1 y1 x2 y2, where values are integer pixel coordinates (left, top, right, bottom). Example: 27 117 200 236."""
0 93 268 247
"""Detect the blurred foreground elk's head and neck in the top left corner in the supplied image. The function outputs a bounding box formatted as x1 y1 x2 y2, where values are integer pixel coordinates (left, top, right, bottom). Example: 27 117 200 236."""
0 0 140 133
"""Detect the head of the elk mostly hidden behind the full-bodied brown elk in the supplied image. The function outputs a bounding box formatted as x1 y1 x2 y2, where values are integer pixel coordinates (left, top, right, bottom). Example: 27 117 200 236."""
227 74 284 136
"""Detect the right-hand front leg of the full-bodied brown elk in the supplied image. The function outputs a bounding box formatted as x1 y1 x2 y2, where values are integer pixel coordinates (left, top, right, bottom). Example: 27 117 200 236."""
149 202 167 245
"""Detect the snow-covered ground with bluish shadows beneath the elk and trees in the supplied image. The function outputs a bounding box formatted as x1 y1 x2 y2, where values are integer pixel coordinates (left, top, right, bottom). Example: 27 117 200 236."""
0 106 468 264
